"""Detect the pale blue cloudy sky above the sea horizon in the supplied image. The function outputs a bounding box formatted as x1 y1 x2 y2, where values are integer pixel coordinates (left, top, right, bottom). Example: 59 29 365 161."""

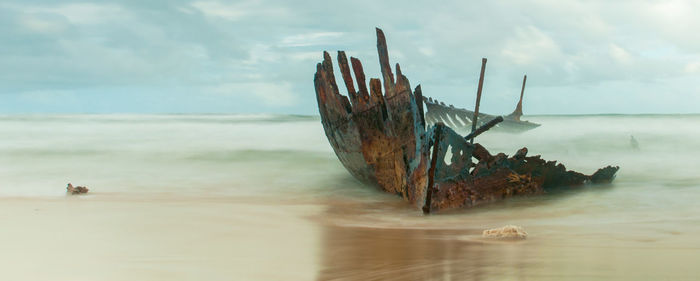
0 0 700 115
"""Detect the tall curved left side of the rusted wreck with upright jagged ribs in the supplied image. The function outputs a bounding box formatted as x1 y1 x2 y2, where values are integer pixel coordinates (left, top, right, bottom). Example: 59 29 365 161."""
314 29 430 203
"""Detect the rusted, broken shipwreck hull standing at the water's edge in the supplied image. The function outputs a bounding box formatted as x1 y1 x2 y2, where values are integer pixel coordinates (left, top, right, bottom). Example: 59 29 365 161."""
314 29 618 213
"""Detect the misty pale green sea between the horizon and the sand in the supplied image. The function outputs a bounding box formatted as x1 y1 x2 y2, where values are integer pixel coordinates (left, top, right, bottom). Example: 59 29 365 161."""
0 114 700 208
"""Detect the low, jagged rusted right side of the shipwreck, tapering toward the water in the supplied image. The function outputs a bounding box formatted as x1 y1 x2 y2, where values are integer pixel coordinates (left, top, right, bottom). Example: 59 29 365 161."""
429 123 619 211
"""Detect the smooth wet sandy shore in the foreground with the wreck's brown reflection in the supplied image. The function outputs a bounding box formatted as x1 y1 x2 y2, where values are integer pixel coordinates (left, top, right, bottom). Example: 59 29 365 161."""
0 193 700 280
